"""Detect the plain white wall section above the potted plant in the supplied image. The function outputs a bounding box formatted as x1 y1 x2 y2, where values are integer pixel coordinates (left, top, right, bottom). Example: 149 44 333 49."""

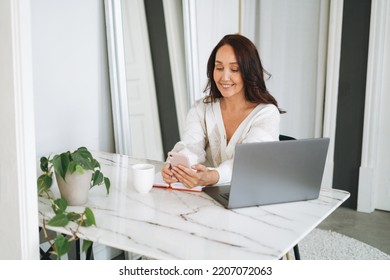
31 0 114 156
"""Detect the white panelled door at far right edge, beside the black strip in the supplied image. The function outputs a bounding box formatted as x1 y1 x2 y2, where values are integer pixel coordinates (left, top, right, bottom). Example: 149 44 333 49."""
358 1 390 213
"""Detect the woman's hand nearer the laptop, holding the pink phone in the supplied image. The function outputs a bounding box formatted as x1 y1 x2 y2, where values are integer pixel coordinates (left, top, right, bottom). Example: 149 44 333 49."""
170 164 219 188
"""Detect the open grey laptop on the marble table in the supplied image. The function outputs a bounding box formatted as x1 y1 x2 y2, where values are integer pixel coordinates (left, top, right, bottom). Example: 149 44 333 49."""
203 138 329 209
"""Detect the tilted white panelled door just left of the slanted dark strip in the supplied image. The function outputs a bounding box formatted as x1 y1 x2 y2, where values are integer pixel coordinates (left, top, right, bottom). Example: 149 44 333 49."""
122 0 164 160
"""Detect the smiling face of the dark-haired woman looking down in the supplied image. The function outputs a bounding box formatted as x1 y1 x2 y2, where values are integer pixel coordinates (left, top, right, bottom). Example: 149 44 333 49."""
214 45 245 97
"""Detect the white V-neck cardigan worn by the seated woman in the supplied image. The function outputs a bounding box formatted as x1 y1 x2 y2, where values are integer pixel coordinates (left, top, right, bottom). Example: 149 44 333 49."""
172 99 280 184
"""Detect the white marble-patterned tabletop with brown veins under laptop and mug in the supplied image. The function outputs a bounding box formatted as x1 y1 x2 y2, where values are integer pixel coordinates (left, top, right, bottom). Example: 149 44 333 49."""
39 152 349 260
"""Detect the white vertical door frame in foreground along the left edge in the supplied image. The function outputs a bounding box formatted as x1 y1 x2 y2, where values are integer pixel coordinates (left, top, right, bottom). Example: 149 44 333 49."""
0 0 39 259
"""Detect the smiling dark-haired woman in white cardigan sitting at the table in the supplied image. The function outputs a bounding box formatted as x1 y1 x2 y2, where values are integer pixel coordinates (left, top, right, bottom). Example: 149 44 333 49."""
162 34 280 188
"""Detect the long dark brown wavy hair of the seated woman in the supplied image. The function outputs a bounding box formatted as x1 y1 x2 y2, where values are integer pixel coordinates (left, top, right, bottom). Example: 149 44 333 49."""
204 34 282 112
